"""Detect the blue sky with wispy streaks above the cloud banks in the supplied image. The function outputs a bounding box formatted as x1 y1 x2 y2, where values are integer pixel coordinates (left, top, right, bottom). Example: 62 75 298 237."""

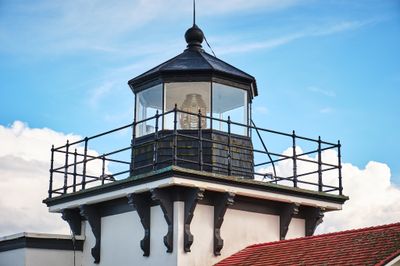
0 0 400 184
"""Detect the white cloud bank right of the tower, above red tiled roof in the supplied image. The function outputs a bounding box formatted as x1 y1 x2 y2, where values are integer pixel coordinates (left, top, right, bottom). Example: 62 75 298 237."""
259 147 400 233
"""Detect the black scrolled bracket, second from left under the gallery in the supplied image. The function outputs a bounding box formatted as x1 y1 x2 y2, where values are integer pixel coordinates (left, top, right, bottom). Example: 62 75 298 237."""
80 205 101 263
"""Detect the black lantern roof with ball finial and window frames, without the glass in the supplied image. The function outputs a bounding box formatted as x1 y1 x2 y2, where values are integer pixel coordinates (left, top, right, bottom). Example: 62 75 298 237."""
128 24 258 138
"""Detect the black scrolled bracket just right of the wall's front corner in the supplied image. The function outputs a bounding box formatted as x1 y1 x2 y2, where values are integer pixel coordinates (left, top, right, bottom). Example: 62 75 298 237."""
183 188 204 252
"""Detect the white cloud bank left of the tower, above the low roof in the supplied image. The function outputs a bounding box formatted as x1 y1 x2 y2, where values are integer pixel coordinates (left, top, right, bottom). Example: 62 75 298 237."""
0 121 80 235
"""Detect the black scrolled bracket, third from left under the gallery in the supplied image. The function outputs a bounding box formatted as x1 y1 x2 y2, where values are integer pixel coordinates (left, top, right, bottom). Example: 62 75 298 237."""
128 193 151 257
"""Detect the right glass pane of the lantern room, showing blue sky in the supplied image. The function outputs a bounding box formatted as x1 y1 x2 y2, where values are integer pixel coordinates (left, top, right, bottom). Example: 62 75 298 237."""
212 83 248 135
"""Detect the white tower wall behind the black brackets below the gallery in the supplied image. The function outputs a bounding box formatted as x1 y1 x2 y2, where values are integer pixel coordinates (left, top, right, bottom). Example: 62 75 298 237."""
82 201 304 266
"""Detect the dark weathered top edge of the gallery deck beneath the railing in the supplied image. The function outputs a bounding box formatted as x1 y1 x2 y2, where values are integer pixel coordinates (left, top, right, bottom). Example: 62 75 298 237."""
43 166 349 207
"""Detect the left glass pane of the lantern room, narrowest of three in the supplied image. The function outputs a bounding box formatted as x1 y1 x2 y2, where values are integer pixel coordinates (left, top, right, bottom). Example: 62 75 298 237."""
135 84 162 137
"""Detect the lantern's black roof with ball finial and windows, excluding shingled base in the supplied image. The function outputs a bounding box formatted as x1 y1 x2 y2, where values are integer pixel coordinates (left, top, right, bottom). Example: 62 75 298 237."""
128 24 257 137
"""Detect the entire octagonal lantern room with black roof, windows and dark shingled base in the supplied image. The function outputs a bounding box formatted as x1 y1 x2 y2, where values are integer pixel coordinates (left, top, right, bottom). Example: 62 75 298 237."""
128 24 257 178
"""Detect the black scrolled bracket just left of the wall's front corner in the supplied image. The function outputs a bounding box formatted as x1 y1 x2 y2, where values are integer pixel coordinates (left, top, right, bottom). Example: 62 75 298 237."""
150 188 174 253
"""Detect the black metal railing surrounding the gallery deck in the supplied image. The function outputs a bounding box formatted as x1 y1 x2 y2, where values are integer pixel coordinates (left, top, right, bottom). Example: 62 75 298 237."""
48 106 343 198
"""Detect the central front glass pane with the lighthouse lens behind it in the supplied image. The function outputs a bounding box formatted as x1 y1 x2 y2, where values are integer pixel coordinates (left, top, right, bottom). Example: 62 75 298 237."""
164 82 211 129
